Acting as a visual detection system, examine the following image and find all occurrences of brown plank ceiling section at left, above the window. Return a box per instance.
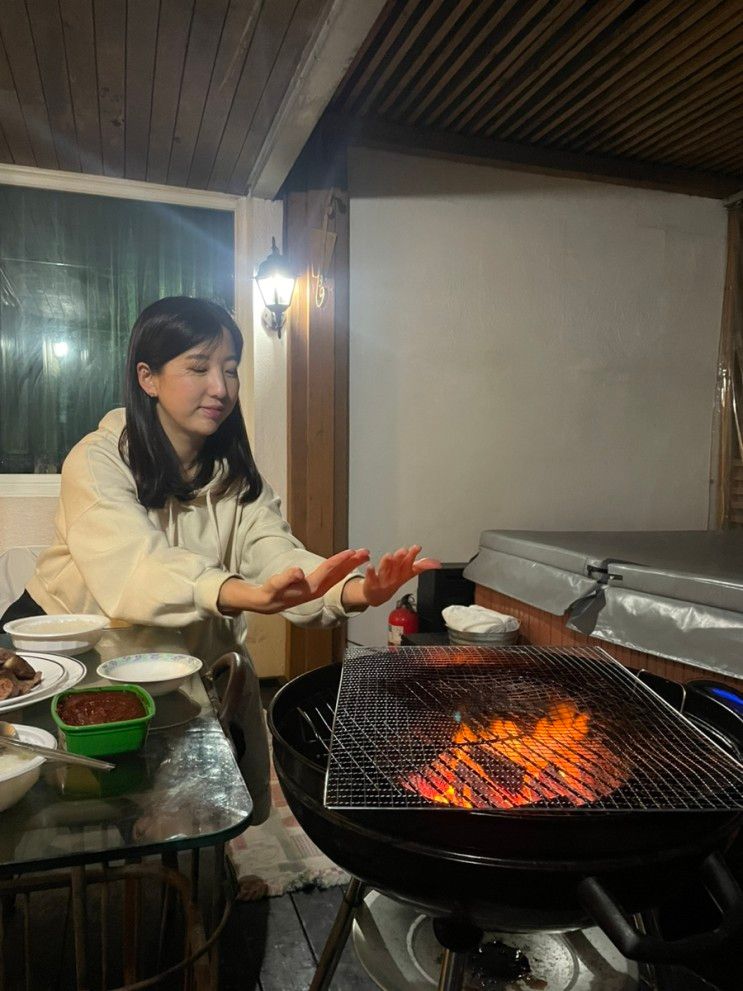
[0,0,328,194]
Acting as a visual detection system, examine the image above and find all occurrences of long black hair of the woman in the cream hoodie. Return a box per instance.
[119,296,263,509]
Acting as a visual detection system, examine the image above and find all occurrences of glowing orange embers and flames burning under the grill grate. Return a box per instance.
[401,701,626,809]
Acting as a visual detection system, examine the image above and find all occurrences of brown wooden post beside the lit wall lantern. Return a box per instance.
[284,131,349,677]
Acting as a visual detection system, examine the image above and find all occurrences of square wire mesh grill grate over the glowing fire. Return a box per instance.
[325,647,743,813]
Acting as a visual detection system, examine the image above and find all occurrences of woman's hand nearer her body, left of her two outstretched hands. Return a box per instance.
[217,549,369,615]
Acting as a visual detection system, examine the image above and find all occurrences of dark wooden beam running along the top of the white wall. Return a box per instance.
[326,115,740,199]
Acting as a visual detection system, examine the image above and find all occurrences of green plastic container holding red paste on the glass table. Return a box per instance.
[52,685,155,757]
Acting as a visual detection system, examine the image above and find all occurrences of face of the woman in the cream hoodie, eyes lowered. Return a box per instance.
[137,330,240,464]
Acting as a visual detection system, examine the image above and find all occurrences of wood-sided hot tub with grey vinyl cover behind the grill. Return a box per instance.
[464,530,743,682]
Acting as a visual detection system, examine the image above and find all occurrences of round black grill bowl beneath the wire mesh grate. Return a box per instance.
[268,665,741,932]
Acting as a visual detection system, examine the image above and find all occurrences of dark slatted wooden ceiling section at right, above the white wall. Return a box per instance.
[330,0,743,188]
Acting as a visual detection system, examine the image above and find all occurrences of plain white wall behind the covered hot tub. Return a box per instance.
[349,150,726,643]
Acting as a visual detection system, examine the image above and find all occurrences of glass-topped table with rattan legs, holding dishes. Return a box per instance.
[0,627,253,987]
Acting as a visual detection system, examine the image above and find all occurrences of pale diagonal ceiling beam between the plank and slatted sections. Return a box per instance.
[248,0,384,199]
